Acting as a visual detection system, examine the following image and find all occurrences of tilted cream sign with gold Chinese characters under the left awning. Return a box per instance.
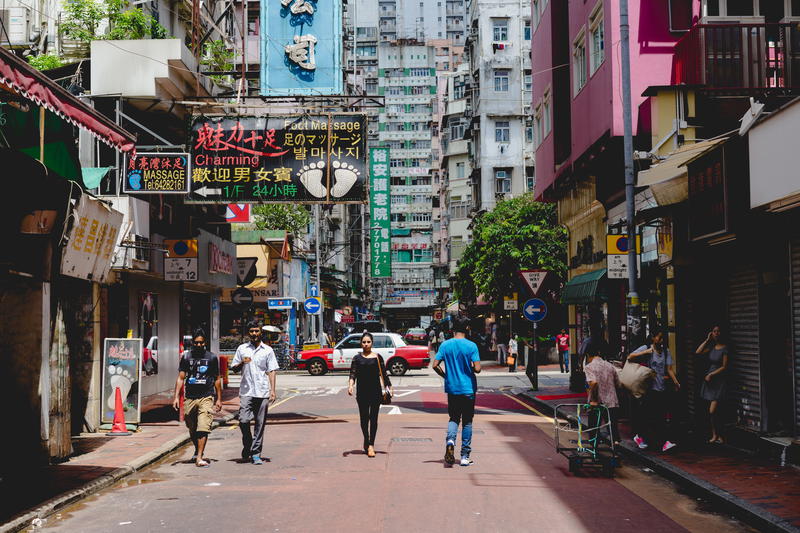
[61,194,123,283]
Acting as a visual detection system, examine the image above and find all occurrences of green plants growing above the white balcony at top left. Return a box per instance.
[61,0,167,42]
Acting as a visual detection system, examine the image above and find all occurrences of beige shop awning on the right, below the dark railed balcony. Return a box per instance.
[637,138,727,205]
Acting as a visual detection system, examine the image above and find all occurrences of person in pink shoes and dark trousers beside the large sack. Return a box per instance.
[628,331,680,452]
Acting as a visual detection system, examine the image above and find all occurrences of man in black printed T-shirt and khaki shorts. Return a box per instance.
[172,329,222,467]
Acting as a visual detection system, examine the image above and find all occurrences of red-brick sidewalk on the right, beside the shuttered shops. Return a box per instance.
[518,380,800,532]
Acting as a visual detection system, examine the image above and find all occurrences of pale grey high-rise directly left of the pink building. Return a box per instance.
[464,0,534,212]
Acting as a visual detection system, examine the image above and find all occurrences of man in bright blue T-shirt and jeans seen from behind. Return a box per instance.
[433,319,481,466]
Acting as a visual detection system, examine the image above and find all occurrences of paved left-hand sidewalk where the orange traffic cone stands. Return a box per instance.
[0,388,239,533]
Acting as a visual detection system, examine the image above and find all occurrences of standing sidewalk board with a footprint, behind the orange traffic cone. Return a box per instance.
[100,339,142,424]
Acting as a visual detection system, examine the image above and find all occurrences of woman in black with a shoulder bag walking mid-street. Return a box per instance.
[347,331,392,457]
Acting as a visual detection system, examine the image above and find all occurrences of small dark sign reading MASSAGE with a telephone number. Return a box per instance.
[122,153,191,194]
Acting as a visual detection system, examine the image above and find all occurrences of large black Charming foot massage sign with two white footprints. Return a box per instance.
[187,114,367,204]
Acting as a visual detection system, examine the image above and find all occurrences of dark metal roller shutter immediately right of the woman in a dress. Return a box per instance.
[728,266,762,431]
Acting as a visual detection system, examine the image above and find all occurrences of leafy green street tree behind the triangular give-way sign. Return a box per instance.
[455,194,567,302]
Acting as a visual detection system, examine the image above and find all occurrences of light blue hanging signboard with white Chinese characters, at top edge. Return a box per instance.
[260,0,342,96]
